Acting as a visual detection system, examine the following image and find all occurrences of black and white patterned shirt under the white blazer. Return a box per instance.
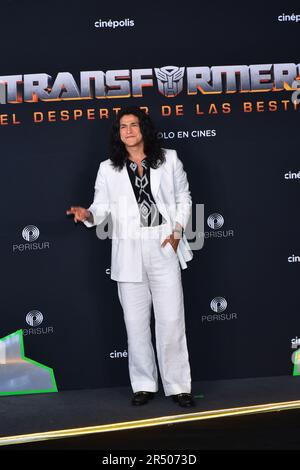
[126,157,166,227]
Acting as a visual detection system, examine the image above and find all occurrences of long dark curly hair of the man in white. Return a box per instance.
[110,106,165,170]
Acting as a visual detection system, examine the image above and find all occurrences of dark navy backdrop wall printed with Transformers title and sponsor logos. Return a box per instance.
[0,0,300,390]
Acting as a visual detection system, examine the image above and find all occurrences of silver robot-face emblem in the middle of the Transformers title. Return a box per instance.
[154,65,185,98]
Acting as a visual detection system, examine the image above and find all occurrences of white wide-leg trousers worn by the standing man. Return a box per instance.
[117,226,191,396]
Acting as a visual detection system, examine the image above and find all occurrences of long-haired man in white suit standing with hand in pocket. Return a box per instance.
[67,107,195,407]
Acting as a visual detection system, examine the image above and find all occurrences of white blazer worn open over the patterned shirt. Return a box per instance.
[84,149,193,282]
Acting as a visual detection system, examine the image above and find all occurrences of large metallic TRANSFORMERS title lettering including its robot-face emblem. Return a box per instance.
[0,63,300,105]
